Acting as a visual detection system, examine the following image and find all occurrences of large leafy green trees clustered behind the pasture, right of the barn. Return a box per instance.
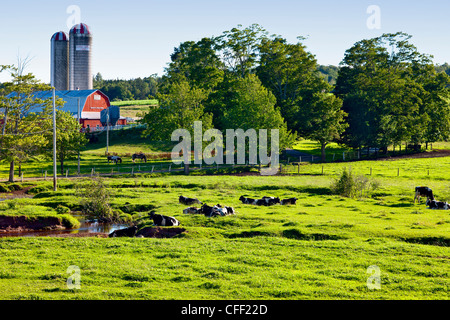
[139,24,450,160]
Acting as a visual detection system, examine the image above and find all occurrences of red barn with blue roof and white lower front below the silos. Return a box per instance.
[5,89,127,131]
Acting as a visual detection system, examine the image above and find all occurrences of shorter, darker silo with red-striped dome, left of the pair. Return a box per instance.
[50,31,69,90]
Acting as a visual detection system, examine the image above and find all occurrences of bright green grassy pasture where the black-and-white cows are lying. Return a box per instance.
[0,158,450,299]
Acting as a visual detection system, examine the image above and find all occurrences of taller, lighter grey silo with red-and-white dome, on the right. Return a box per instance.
[69,23,93,90]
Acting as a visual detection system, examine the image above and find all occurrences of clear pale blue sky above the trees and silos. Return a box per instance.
[0,0,450,82]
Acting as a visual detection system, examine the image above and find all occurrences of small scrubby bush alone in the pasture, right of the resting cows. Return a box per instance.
[331,169,379,198]
